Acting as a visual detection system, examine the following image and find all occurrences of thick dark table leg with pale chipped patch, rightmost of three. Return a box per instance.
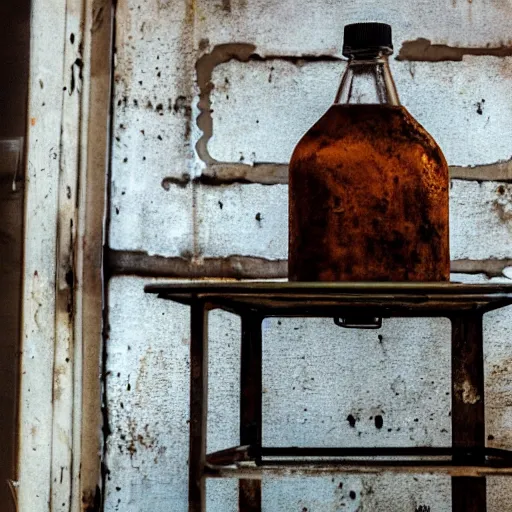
[452,312,487,512]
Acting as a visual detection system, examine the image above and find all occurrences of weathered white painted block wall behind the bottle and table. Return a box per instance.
[106,0,512,512]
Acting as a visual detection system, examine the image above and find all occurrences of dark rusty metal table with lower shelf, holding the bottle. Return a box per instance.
[145,281,512,512]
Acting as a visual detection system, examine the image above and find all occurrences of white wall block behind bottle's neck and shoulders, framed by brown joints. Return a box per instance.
[209,56,512,165]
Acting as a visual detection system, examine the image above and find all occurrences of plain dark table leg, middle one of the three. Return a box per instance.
[238,312,263,512]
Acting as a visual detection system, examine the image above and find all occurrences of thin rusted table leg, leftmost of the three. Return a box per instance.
[188,301,208,512]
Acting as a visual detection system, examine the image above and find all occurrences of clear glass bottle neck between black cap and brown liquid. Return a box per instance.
[334,53,400,105]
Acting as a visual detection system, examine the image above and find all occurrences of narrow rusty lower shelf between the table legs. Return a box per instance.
[205,446,512,480]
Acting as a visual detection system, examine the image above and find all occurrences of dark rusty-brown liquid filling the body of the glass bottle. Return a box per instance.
[288,105,450,281]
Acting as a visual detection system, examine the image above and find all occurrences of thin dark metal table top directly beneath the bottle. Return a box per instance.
[145,280,512,316]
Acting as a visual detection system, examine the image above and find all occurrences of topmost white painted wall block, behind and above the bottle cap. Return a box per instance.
[194,0,510,55]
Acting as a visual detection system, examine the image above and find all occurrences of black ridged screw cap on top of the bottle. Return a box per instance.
[343,23,393,57]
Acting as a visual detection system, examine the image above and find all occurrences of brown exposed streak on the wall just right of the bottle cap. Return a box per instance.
[396,37,512,62]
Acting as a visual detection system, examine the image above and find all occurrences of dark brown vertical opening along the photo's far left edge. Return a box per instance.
[0,0,30,512]
